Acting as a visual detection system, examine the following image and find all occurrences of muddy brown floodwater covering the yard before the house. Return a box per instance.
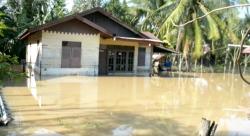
[0,73,250,136]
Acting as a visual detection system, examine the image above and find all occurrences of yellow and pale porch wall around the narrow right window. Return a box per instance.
[100,39,153,75]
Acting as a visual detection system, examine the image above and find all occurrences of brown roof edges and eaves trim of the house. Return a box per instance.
[19,7,163,44]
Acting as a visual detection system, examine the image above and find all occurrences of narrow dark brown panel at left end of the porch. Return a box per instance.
[99,45,107,75]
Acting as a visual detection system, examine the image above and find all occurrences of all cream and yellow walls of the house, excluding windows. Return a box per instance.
[26,31,152,76]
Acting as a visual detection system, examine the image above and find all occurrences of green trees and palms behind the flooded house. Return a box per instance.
[0,0,250,78]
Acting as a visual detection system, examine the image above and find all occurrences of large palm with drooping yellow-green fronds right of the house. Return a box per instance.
[159,0,223,59]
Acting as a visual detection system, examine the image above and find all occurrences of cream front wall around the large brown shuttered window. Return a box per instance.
[42,31,100,75]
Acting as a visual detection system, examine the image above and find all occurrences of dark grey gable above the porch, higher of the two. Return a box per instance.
[83,11,142,38]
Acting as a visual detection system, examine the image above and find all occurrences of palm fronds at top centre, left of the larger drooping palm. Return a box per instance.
[128,0,175,34]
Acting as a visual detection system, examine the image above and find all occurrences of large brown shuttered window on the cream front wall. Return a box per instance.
[61,41,81,68]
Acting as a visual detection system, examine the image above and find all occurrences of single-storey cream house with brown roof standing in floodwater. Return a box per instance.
[20,8,171,76]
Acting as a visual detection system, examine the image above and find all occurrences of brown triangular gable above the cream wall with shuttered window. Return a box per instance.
[45,19,98,34]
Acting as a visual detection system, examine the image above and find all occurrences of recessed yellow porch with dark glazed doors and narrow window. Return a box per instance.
[98,39,153,75]
